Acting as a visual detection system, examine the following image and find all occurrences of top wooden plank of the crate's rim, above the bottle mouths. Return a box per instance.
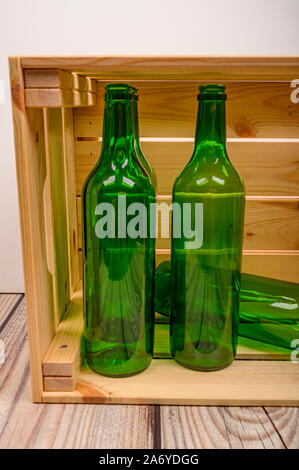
[21,55,299,81]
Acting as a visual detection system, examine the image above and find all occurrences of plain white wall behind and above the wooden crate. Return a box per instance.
[0,0,299,292]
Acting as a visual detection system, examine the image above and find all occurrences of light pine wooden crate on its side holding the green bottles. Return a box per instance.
[9,57,299,405]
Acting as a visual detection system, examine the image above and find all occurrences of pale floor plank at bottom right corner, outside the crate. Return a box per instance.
[266,407,299,449]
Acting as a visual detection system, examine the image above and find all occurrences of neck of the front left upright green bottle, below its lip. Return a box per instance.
[102,100,133,157]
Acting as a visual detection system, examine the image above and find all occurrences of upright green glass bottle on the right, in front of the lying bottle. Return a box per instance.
[170,85,245,371]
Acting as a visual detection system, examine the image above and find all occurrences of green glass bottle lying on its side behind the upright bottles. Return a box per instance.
[155,261,299,350]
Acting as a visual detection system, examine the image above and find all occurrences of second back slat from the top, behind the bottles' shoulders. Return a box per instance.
[75,141,299,196]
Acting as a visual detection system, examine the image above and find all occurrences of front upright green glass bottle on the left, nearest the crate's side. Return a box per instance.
[82,84,155,377]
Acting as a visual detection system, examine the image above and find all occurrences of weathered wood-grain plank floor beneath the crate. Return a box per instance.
[0,294,299,449]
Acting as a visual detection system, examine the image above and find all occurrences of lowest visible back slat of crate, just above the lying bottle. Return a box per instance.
[156,250,299,282]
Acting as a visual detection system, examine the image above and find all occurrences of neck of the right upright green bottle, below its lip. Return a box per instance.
[195,100,226,146]
